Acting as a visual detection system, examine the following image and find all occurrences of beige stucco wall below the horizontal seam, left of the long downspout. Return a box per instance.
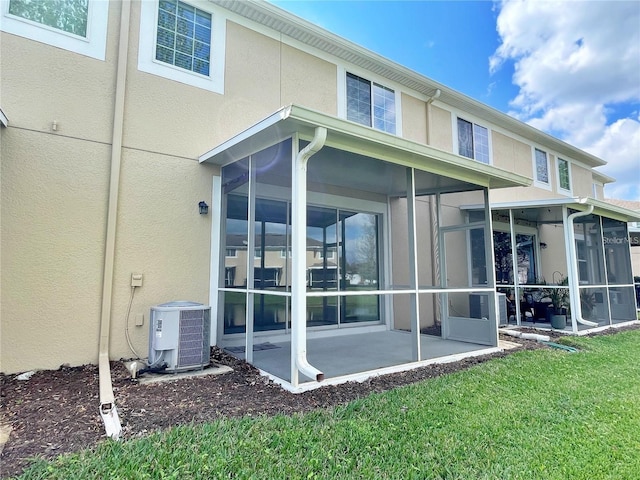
[0,128,110,373]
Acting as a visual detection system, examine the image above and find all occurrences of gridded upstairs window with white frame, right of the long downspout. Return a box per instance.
[138,0,226,93]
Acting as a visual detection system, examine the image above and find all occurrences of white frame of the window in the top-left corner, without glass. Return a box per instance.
[0,0,109,61]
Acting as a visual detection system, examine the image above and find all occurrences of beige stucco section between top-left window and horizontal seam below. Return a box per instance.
[0,32,115,142]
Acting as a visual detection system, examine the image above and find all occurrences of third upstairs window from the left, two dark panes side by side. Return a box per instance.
[347,73,396,134]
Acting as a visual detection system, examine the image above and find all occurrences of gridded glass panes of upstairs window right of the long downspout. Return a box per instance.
[156,0,211,75]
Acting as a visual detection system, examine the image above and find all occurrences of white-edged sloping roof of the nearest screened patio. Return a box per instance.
[199,105,531,191]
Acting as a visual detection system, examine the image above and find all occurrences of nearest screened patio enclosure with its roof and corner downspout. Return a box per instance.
[200,105,529,391]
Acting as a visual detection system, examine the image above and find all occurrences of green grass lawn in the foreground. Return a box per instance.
[13,330,640,480]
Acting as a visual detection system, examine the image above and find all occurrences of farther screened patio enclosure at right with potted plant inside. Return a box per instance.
[463,198,638,333]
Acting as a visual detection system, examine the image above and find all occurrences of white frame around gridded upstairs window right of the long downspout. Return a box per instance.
[138,0,227,94]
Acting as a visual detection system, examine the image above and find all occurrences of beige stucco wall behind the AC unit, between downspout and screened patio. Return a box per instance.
[111,150,217,358]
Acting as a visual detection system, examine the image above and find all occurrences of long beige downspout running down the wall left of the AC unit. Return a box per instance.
[98,0,131,440]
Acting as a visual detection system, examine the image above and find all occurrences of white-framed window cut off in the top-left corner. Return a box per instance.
[0,0,109,60]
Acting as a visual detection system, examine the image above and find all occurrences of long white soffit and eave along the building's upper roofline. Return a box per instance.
[209,0,607,167]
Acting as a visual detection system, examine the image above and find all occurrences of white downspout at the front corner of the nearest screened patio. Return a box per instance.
[291,127,327,387]
